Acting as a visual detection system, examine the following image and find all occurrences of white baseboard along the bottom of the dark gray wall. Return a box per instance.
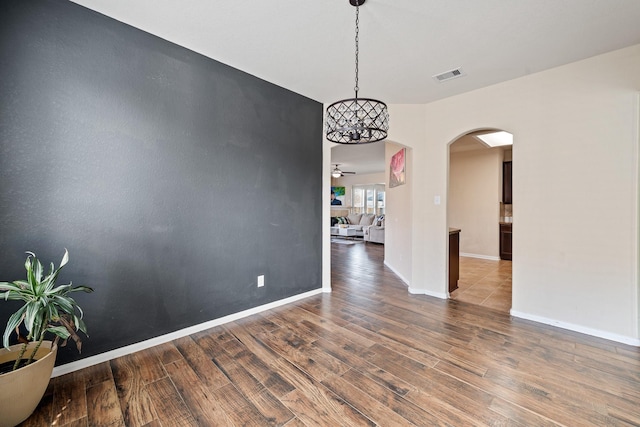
[51,288,326,378]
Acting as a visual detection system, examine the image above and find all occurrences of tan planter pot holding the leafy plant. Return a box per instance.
[0,341,58,427]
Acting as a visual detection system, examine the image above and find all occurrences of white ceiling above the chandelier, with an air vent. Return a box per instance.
[74,0,640,174]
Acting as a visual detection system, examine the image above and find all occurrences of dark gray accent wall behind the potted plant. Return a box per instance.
[0,0,322,364]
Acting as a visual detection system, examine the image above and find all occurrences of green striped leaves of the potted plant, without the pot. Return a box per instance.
[0,249,93,370]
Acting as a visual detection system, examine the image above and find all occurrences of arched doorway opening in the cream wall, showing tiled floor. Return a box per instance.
[447,129,514,312]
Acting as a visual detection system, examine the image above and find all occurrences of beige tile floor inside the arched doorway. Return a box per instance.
[451,257,511,313]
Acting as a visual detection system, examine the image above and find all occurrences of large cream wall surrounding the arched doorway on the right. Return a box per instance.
[385,45,640,344]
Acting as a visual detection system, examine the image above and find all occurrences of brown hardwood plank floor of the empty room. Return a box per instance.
[23,244,640,427]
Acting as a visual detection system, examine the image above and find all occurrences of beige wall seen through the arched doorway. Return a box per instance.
[447,143,503,259]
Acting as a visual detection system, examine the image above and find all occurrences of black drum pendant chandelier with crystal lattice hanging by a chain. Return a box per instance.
[326,0,389,144]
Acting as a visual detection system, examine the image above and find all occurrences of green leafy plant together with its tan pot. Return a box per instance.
[0,249,93,427]
